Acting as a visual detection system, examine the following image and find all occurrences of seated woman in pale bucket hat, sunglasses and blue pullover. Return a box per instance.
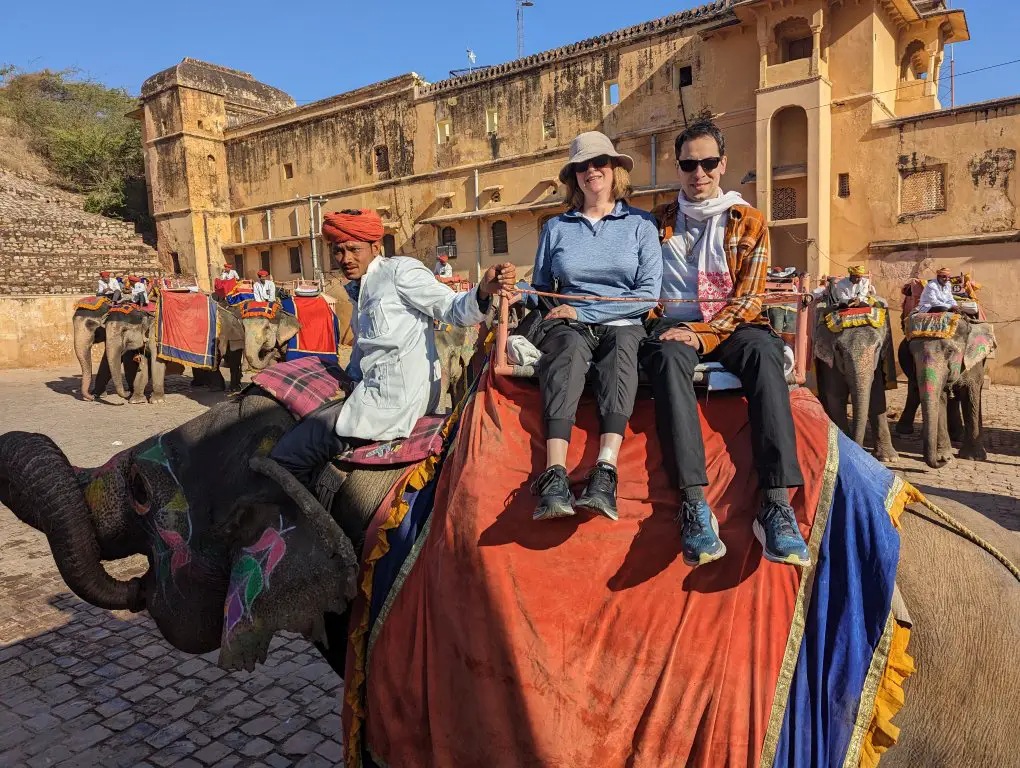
[532,131,662,520]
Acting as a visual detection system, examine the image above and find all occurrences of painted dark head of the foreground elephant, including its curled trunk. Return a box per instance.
[0,396,356,669]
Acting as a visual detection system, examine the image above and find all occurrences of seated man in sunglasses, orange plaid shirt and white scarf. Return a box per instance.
[641,120,811,566]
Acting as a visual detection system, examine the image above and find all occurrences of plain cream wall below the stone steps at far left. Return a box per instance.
[0,296,79,369]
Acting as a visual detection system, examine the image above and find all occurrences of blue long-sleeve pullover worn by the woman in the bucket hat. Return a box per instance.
[531,200,662,323]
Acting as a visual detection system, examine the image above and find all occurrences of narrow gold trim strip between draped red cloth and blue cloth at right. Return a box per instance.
[758,421,839,768]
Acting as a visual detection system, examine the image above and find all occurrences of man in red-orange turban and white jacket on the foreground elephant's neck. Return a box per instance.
[270,209,516,490]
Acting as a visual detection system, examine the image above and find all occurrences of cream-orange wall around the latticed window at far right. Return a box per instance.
[831,104,1020,383]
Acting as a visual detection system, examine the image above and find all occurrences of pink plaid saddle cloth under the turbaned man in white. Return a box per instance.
[252,357,446,466]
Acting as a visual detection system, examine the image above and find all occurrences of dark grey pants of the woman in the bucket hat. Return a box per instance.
[539,320,645,440]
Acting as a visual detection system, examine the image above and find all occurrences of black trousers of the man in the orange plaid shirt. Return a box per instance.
[640,320,804,489]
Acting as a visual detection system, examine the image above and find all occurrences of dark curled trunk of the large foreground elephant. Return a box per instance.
[0,432,145,611]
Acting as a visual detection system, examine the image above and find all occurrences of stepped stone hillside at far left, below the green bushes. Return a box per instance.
[0,169,160,296]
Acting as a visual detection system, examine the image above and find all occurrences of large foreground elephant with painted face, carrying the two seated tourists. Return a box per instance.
[0,387,1020,768]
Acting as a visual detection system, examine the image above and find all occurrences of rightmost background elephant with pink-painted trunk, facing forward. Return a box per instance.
[897,315,996,469]
